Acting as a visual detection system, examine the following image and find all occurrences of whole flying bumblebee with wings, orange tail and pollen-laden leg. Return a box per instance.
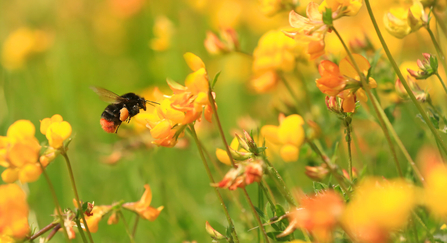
[90,87,158,133]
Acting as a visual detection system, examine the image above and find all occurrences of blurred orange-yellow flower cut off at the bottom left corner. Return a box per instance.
[0,184,29,238]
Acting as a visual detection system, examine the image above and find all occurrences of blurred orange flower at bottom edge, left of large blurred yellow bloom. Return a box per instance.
[277,191,344,242]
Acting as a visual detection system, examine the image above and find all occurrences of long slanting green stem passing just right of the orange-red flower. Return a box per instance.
[332,28,403,177]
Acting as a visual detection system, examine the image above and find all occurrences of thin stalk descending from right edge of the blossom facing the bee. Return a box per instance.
[208,89,270,243]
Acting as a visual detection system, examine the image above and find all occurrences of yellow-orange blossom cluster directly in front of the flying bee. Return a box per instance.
[136,52,213,147]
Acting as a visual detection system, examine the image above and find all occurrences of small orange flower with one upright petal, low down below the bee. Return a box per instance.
[123,184,164,221]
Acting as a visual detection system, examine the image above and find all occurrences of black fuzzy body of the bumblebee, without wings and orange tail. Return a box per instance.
[101,93,146,126]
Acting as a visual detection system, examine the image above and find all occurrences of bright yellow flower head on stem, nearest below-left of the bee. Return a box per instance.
[40,114,72,149]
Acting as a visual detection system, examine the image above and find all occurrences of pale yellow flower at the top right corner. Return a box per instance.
[383,0,428,39]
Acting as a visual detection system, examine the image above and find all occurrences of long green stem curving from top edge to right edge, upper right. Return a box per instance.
[365,0,447,156]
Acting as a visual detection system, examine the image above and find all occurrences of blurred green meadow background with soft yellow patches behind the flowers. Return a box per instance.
[0,0,444,242]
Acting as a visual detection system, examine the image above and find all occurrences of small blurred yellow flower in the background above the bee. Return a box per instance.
[150,16,174,51]
